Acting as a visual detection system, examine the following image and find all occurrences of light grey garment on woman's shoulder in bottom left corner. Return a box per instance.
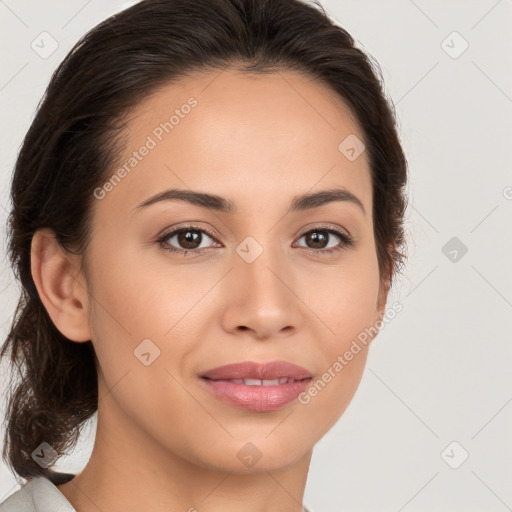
[0,476,76,512]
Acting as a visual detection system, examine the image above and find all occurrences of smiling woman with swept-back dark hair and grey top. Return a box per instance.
[0,0,406,512]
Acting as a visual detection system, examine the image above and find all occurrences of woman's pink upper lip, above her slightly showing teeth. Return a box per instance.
[201,361,311,380]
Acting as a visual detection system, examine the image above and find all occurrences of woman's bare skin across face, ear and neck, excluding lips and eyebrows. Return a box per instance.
[32,70,388,512]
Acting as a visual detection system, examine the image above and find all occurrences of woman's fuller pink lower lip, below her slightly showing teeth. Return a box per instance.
[201,377,311,412]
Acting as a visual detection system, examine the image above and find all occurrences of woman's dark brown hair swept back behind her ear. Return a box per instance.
[1,0,407,481]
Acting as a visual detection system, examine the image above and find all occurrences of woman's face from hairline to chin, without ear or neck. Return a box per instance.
[74,70,385,472]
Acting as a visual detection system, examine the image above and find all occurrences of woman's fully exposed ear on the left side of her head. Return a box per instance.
[30,228,91,342]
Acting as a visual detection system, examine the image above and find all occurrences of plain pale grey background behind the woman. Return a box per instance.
[0,0,512,512]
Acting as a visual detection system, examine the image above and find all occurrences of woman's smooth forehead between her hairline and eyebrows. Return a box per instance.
[98,70,371,218]
